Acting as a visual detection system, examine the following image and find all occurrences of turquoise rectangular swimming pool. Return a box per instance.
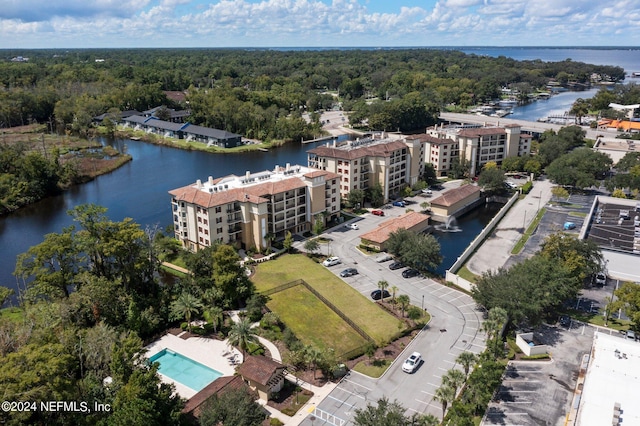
[149,349,222,392]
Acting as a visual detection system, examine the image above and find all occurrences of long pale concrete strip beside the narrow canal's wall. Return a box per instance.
[466,180,553,275]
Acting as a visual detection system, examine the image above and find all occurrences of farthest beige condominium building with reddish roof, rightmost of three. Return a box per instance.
[425,124,532,176]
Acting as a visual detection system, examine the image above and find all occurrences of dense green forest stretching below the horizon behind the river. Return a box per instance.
[0,49,624,141]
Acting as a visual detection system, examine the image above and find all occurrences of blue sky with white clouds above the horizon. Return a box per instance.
[0,0,640,49]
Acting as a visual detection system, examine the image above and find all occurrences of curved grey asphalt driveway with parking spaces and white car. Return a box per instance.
[298,211,486,425]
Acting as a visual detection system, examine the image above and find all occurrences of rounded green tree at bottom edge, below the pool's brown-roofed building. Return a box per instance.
[198,389,268,426]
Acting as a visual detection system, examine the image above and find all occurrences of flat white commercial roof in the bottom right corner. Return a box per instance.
[576,332,640,426]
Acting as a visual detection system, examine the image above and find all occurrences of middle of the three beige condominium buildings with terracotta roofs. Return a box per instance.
[307,134,424,201]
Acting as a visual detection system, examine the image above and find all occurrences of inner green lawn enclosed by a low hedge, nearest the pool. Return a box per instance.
[267,285,367,355]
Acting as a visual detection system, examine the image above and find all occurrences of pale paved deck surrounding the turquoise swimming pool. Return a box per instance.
[145,334,242,399]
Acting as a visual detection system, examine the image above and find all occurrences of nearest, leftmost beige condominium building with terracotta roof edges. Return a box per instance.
[169,164,340,251]
